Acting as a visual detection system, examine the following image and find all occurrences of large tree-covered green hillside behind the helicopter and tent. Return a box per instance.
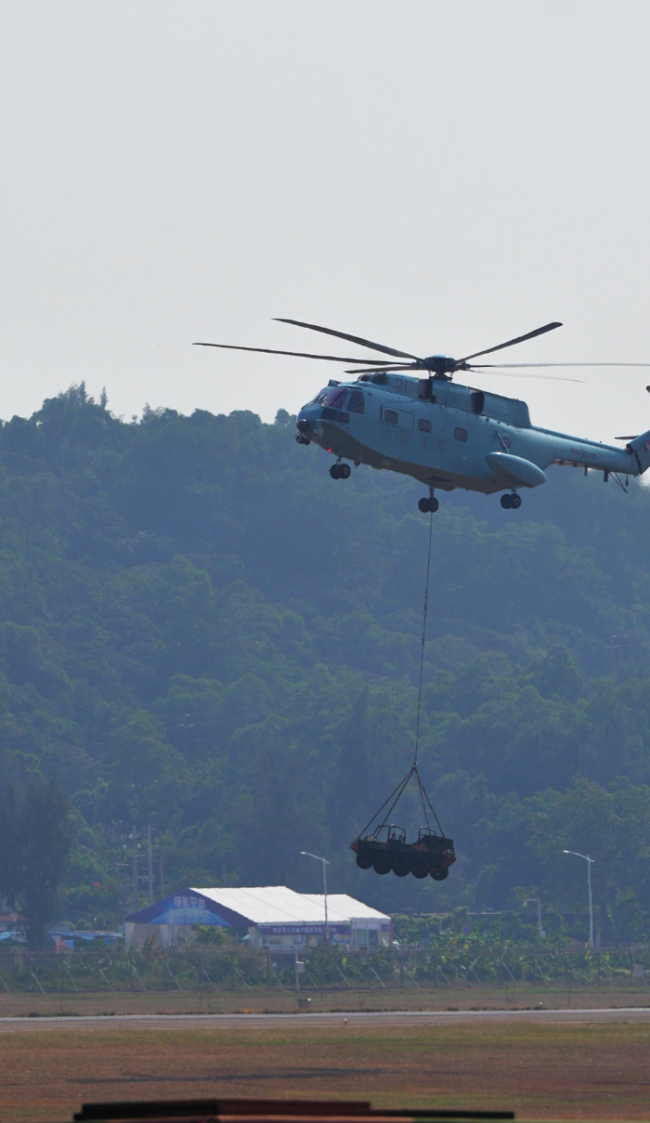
[0,387,650,939]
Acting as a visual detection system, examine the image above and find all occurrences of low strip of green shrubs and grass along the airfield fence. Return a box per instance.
[6,934,650,997]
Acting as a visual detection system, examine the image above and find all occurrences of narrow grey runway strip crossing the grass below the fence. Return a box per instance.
[0,1006,650,1033]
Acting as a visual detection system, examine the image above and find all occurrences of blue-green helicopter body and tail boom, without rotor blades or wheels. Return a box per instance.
[297,373,650,494]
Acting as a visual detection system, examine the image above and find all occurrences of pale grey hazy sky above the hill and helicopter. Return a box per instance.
[0,0,650,439]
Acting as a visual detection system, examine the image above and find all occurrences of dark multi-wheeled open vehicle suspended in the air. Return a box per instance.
[351,824,456,882]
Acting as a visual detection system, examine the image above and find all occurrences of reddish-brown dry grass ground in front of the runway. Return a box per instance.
[0,1016,650,1123]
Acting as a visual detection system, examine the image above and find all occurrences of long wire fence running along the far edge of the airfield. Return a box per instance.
[0,944,650,1004]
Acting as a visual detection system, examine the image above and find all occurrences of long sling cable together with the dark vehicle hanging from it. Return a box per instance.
[351,514,456,882]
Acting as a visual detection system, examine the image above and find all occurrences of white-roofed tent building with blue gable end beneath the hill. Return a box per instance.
[125,885,392,952]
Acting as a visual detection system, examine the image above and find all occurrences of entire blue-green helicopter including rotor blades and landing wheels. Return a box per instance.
[195,318,650,512]
